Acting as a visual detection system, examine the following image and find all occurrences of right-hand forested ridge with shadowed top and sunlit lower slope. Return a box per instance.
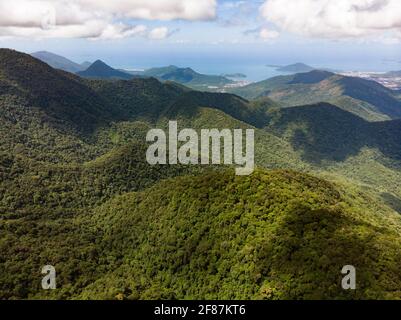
[265,103,401,208]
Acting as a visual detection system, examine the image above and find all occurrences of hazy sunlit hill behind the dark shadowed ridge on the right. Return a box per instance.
[230,70,401,121]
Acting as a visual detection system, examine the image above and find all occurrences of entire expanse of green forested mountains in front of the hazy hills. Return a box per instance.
[0,49,401,299]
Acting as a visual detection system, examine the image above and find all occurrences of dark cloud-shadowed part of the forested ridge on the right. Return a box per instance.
[269,103,401,161]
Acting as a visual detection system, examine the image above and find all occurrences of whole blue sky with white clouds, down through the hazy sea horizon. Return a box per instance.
[0,0,401,72]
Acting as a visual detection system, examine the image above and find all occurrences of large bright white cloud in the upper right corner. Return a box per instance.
[260,0,401,39]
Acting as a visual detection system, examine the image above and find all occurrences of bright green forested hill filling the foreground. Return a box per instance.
[5,171,401,299]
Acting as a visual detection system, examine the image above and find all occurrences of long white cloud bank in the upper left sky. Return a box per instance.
[0,0,216,39]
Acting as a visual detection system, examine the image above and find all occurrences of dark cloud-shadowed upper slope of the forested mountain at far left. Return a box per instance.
[0,49,113,141]
